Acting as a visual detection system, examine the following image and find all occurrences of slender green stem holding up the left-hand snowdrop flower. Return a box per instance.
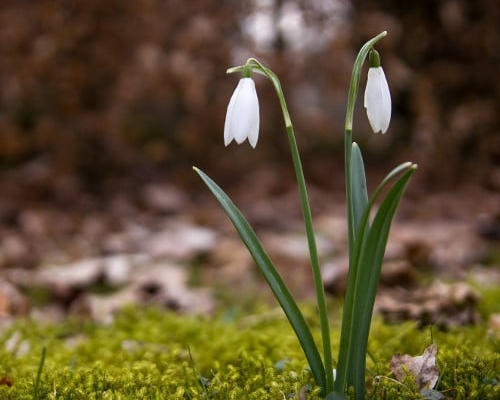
[247,58,333,394]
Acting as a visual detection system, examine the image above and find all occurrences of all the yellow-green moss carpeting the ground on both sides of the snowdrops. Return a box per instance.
[0,289,500,400]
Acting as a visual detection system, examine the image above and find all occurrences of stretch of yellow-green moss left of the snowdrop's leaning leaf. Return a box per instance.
[0,309,317,399]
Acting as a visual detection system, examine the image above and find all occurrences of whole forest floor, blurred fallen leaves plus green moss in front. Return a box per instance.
[0,164,500,399]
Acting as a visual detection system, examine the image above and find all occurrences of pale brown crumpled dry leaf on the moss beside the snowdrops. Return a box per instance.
[390,344,439,392]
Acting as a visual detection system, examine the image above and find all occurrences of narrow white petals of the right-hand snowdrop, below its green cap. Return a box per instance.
[365,67,391,133]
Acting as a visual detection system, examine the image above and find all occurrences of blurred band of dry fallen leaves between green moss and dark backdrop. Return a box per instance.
[0,162,500,326]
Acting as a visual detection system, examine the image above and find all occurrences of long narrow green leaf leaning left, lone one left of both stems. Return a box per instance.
[193,168,326,390]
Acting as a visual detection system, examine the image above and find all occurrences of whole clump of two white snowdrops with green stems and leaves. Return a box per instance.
[195,32,416,400]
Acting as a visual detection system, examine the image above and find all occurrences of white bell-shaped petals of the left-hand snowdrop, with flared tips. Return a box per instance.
[224,78,259,148]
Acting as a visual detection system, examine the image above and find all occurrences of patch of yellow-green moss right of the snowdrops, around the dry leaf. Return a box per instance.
[368,320,500,400]
